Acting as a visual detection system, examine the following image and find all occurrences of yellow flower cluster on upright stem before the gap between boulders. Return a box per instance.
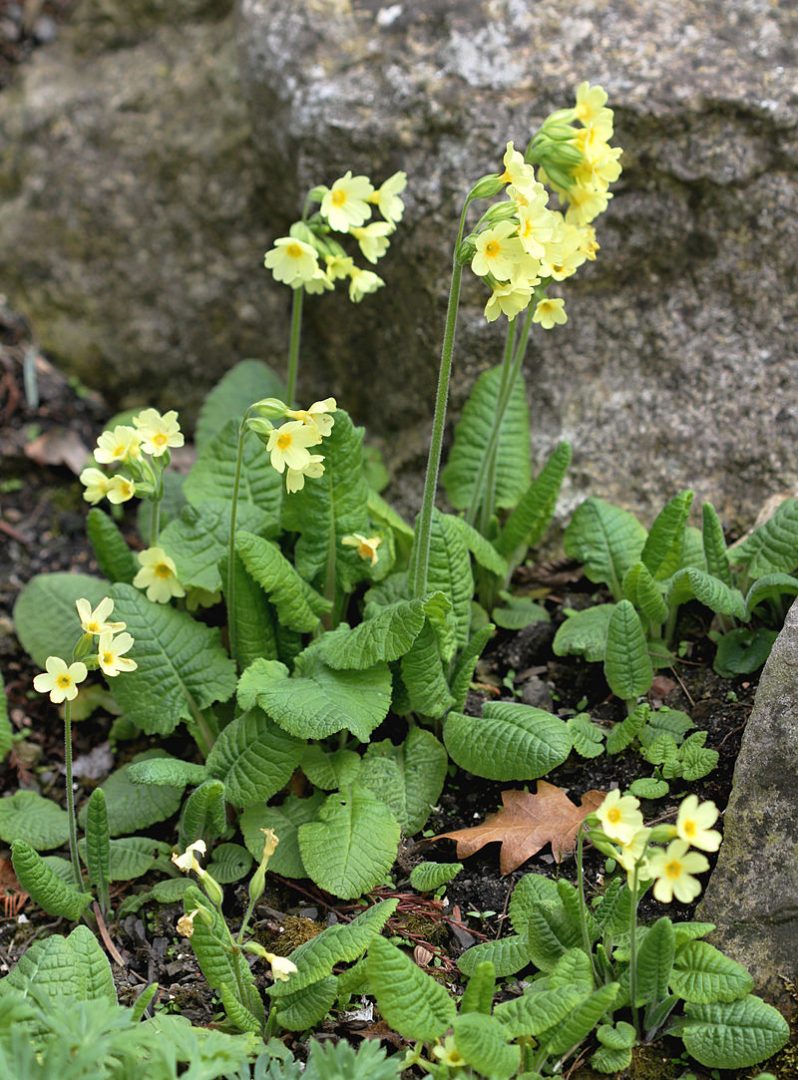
[263,171,407,303]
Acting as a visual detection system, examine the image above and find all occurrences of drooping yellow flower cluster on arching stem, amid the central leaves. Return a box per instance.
[247,397,338,495]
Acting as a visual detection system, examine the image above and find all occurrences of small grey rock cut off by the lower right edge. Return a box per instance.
[698,603,798,1011]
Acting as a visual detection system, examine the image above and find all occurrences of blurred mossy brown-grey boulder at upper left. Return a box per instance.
[0,0,287,409]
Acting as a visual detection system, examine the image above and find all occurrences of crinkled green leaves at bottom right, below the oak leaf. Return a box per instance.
[359,874,789,1080]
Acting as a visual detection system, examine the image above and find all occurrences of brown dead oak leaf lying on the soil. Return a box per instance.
[435,780,605,874]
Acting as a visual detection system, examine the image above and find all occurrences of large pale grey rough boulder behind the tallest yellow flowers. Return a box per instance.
[238,0,798,523]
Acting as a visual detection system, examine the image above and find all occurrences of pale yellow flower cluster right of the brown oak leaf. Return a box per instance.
[596,791,721,904]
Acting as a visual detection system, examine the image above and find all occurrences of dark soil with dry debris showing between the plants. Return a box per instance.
[0,315,795,1080]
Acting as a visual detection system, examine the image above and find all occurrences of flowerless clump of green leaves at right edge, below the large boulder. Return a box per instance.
[554,490,798,682]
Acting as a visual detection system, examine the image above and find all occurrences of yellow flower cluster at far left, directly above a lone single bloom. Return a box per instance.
[80,408,184,504]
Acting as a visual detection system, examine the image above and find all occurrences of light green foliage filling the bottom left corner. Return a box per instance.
[0,927,259,1080]
